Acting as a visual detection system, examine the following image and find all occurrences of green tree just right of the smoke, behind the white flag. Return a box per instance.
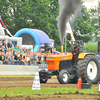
[73,6,95,42]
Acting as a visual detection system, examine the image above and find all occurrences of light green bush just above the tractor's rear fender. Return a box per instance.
[83,42,98,55]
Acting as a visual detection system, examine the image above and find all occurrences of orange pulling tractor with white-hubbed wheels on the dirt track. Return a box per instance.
[39,42,100,84]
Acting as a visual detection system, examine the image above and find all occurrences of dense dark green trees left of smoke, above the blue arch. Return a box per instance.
[0,0,60,45]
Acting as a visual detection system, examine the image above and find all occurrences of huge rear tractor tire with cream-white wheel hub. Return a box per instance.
[76,55,100,84]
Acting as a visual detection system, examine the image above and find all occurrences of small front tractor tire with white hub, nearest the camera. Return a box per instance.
[57,70,69,84]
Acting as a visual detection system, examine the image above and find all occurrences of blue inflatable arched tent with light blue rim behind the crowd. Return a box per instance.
[14,28,52,52]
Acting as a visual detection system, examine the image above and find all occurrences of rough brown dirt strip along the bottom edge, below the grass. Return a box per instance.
[0,91,100,100]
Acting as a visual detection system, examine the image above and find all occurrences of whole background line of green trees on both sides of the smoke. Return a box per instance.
[0,0,100,51]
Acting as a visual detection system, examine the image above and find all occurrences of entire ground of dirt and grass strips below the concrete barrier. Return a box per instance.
[0,75,100,100]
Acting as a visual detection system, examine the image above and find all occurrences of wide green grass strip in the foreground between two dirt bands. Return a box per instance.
[0,87,99,97]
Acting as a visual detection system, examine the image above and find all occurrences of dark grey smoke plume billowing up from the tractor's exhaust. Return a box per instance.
[57,0,94,45]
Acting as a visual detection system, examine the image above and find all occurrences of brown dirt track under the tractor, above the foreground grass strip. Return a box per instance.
[0,77,98,88]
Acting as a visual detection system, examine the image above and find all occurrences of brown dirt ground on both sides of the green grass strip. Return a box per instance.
[0,77,100,100]
